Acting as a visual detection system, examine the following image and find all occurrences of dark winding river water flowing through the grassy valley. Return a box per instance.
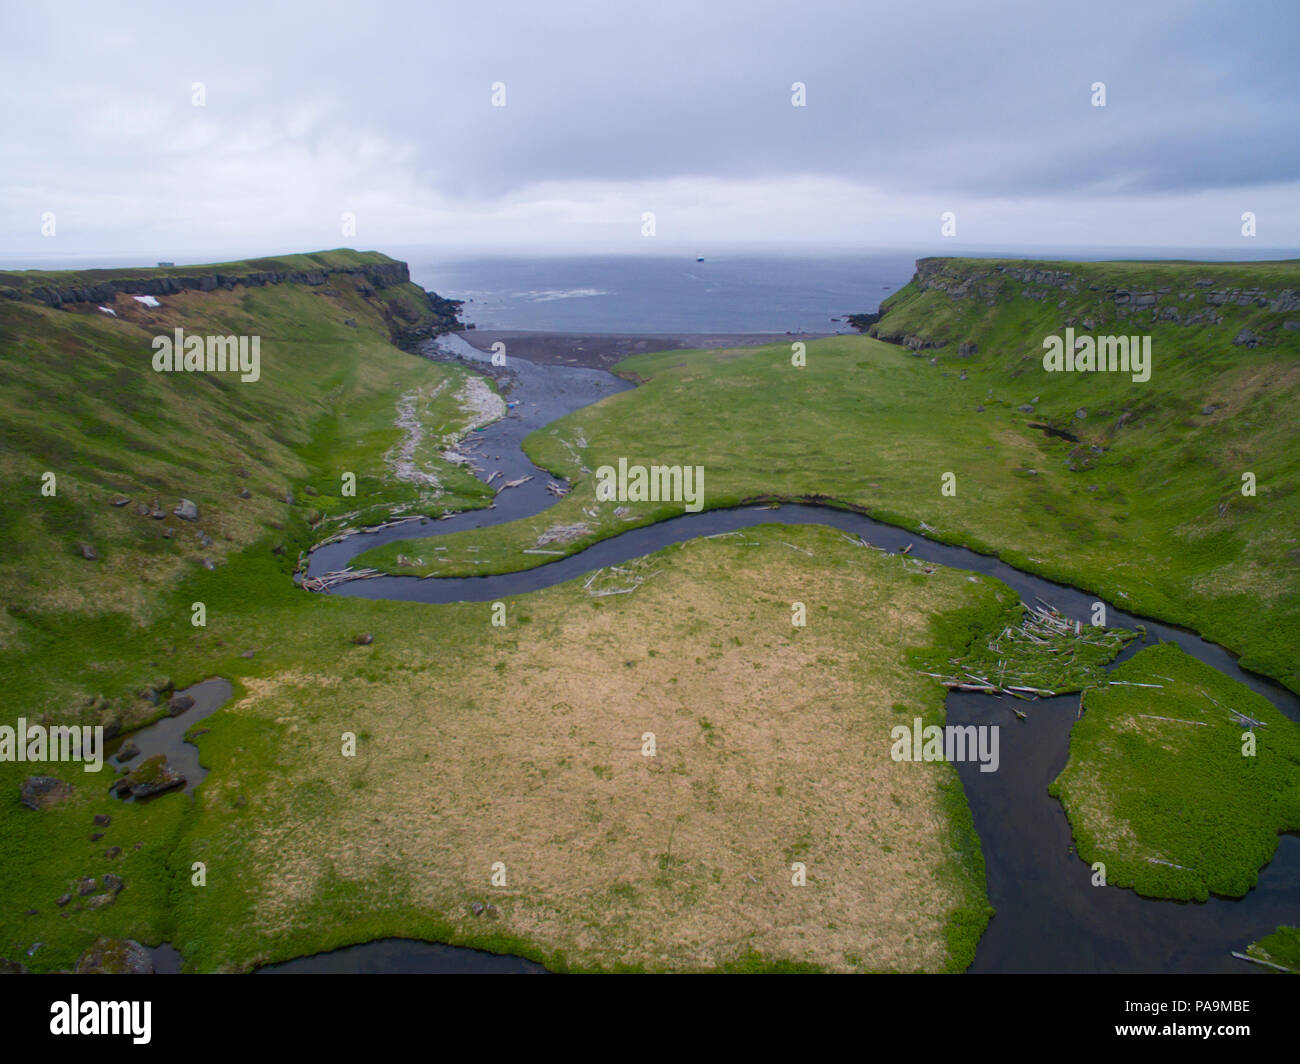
[142,337,1300,973]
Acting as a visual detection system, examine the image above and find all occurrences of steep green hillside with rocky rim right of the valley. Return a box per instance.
[870,259,1300,689]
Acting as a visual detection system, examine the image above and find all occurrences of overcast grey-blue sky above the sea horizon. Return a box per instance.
[0,0,1300,263]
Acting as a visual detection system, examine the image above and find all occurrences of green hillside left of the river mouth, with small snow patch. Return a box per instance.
[0,251,490,722]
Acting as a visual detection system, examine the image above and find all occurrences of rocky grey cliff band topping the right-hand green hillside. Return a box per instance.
[868,259,1300,350]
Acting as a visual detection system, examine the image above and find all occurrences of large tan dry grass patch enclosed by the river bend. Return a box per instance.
[188,525,983,970]
